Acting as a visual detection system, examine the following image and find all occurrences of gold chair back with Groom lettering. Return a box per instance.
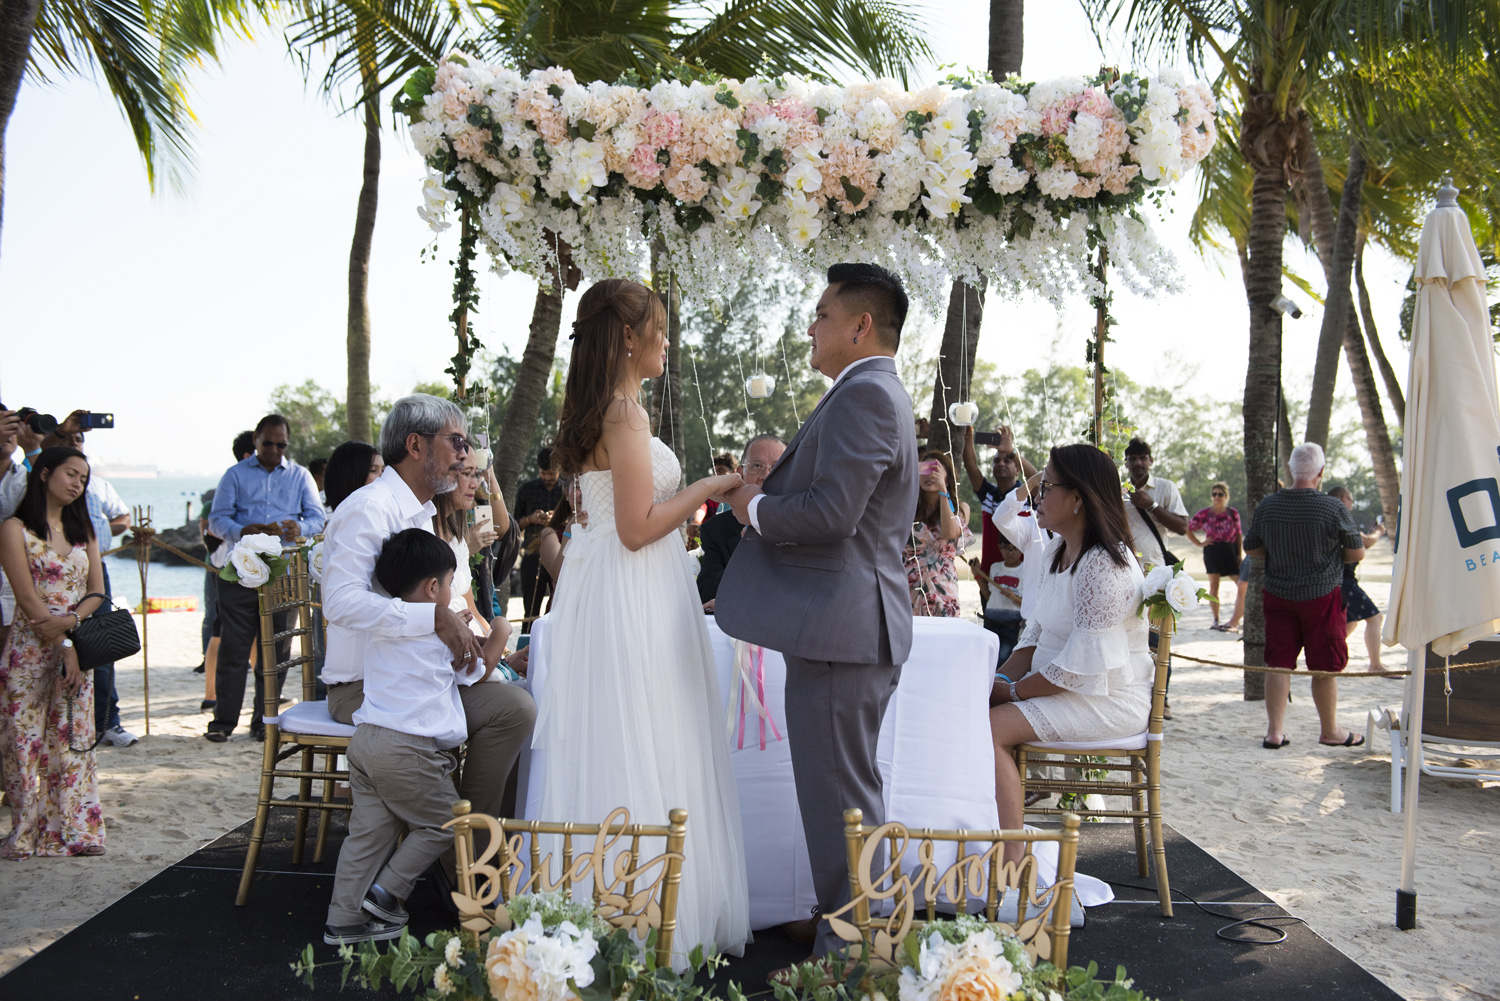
[825,810,1079,969]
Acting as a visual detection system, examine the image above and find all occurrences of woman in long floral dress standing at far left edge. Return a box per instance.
[0,449,104,858]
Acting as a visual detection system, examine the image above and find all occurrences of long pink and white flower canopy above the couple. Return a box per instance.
[396,53,1218,305]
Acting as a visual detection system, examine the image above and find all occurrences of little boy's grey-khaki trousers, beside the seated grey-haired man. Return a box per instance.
[329,723,453,927]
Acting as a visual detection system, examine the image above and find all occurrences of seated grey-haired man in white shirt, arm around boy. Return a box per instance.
[323,393,537,918]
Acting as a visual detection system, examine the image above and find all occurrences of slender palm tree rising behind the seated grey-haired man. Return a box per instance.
[287,0,464,441]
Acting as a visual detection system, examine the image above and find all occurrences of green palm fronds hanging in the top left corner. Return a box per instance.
[0,0,263,258]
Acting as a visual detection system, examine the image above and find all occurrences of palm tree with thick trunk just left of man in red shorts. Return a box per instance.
[1083,0,1500,698]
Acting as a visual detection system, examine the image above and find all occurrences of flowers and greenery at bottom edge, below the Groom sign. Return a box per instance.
[771,915,1146,1001]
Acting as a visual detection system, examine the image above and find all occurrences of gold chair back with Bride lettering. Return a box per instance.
[447,800,687,966]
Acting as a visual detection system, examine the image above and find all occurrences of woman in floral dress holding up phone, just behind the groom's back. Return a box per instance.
[903,452,974,618]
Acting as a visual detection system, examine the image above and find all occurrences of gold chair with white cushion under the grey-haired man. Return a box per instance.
[234,549,354,906]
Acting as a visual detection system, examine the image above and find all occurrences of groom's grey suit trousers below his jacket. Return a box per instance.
[785,654,902,956]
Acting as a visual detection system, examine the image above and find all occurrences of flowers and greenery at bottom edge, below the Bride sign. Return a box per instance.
[293,891,743,1001]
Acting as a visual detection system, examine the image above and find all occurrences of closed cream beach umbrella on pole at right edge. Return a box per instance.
[1383,182,1500,929]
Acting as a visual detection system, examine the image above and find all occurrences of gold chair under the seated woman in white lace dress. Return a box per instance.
[1016,615,1175,917]
